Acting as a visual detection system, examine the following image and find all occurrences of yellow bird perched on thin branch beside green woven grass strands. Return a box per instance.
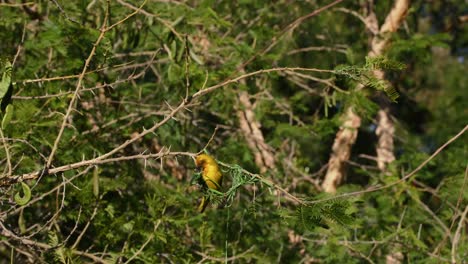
[195,154,223,213]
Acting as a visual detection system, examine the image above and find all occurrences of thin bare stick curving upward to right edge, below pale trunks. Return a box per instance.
[308,125,468,204]
